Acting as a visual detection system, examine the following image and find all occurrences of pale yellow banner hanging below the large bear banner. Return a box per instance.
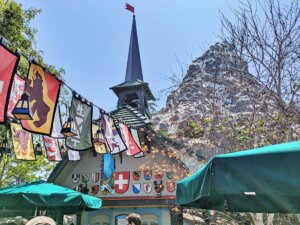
[10,123,35,160]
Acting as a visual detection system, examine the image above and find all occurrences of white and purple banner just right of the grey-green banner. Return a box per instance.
[101,113,127,155]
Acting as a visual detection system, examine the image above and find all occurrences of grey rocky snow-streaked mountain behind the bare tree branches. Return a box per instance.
[152,42,278,166]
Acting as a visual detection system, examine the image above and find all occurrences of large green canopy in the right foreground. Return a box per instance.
[176,141,300,213]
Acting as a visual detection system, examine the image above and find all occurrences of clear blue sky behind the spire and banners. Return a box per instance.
[17,0,238,112]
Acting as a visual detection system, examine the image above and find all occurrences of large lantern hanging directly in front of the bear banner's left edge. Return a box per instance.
[12,92,32,120]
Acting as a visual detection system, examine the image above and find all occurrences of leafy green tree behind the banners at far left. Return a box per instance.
[0,0,64,187]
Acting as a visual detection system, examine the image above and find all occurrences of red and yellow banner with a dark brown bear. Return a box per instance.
[21,64,60,135]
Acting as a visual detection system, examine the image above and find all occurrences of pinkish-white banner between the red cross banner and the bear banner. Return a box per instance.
[7,75,25,118]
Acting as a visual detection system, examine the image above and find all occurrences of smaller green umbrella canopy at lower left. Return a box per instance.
[0,181,102,210]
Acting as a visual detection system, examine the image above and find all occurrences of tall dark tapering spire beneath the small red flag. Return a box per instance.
[125,15,143,81]
